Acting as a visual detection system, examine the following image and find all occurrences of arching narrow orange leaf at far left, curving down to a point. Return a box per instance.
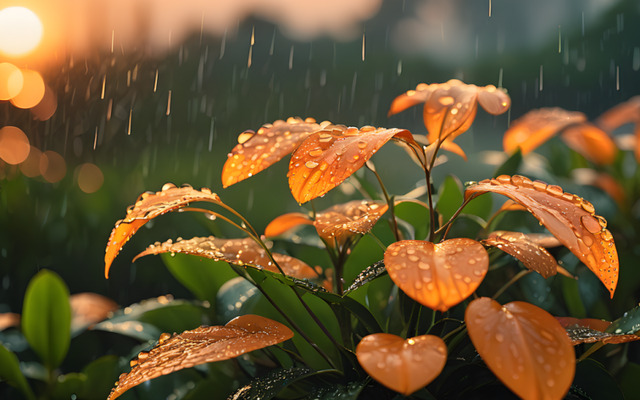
[104,183,222,279]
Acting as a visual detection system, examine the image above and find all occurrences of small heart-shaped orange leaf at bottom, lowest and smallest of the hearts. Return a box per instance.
[356,333,447,396]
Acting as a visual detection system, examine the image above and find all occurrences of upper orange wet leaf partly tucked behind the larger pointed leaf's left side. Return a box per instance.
[222,118,329,187]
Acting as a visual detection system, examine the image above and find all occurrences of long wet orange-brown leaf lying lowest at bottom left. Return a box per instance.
[107,315,293,400]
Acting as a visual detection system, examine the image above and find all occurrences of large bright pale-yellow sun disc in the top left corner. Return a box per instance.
[0,7,43,57]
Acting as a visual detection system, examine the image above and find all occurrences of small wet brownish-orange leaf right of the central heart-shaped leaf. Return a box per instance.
[482,231,558,278]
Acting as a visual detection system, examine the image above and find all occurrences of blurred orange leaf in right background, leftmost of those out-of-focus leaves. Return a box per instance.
[502,108,587,154]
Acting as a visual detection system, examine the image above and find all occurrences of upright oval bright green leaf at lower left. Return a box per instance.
[22,270,71,370]
